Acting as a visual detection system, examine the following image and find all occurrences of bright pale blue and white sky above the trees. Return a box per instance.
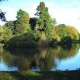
[0,0,80,32]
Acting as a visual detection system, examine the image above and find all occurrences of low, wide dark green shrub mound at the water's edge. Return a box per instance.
[4,31,40,48]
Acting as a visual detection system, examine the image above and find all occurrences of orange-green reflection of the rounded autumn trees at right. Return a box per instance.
[55,44,79,59]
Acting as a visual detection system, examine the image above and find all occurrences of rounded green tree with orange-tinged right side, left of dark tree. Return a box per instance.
[15,9,30,34]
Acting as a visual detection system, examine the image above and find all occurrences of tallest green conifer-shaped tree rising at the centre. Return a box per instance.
[35,2,54,42]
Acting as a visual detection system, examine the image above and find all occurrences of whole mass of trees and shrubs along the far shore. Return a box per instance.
[0,2,79,48]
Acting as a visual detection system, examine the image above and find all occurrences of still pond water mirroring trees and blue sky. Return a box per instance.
[0,44,80,71]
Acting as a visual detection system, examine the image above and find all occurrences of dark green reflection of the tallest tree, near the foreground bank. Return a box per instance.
[39,48,56,71]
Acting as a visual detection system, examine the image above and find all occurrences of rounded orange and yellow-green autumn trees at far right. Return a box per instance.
[55,24,79,40]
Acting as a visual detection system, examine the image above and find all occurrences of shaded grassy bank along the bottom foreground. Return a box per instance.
[0,70,80,80]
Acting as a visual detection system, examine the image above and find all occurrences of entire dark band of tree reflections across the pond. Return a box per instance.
[0,44,79,71]
